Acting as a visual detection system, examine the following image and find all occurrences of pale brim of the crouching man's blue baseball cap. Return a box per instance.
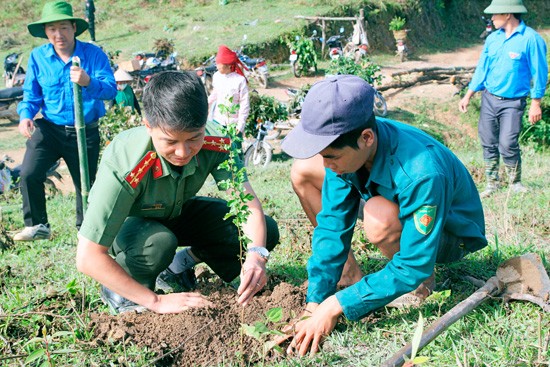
[281,123,340,159]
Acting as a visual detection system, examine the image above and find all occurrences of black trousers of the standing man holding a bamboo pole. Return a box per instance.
[20,119,99,228]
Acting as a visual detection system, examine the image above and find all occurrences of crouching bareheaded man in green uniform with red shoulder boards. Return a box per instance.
[77,71,279,313]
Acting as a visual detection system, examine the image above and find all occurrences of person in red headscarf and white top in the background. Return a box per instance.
[208,45,250,144]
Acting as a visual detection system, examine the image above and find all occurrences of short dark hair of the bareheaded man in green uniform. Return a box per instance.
[143,71,208,131]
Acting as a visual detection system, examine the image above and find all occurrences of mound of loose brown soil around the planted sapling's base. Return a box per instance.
[90,280,305,366]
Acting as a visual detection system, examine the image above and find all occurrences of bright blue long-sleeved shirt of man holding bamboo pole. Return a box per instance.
[17,40,117,126]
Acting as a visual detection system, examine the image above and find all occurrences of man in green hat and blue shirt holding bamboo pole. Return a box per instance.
[13,1,116,241]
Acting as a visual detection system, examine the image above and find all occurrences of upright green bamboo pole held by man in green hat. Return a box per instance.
[73,56,90,214]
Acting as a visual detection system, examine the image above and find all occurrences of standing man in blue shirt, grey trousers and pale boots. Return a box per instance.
[458,0,548,197]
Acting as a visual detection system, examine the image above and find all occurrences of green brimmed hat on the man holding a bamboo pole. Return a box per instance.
[27,1,88,38]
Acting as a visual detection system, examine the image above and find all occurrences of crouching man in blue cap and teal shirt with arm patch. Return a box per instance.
[278,75,487,356]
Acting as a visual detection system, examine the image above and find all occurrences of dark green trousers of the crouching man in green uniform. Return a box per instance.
[111,196,279,289]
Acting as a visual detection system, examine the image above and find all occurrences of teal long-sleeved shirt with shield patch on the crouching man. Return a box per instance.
[307,117,487,320]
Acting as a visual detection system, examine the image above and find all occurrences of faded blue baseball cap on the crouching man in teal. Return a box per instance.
[281,75,374,159]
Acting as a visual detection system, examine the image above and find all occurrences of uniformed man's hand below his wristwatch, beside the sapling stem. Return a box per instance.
[237,252,267,306]
